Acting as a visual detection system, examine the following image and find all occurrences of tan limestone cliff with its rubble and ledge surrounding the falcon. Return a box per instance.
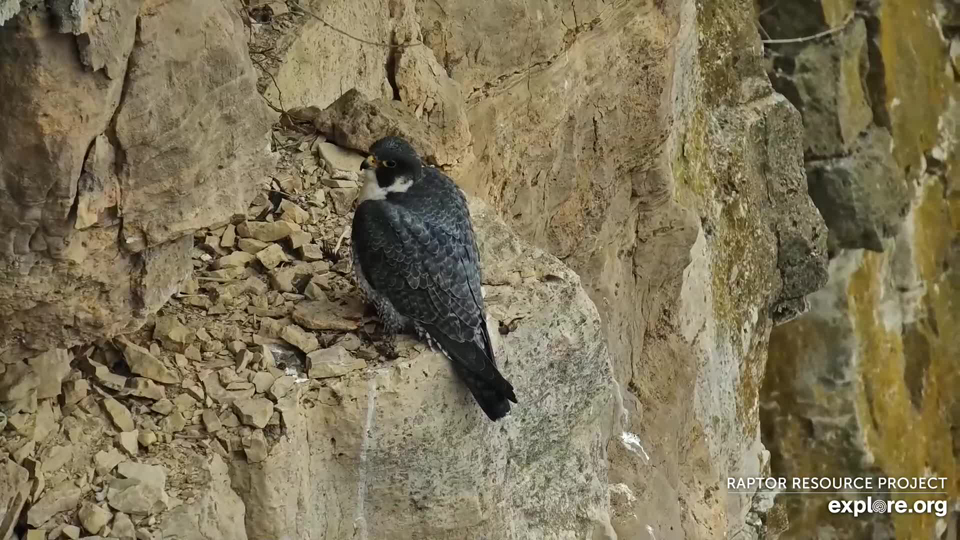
[0,0,832,540]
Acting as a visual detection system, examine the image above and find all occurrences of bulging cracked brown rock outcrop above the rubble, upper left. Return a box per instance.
[0,0,271,354]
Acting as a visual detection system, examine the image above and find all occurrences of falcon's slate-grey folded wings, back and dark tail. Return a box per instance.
[352,168,517,420]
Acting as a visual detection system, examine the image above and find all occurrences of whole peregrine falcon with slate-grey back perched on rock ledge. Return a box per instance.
[352,137,517,420]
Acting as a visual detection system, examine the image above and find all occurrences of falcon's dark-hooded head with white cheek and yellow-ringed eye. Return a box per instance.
[360,137,423,202]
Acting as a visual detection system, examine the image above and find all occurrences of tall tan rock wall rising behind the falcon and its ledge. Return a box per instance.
[254,0,827,538]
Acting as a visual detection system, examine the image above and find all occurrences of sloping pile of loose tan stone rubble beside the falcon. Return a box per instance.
[0,126,424,540]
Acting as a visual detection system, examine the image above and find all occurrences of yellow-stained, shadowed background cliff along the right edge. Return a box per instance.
[760,0,960,539]
